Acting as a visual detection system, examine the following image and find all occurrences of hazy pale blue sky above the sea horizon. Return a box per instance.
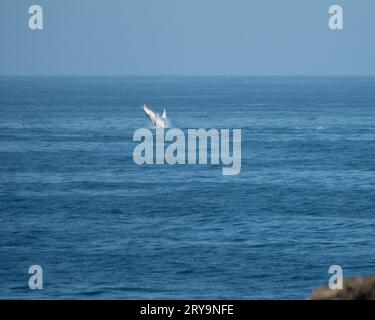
[0,0,375,75]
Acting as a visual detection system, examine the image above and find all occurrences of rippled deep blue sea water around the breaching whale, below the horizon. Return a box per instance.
[0,77,375,299]
